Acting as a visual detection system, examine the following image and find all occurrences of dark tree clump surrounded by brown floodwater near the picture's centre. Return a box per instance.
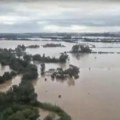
[51,65,79,79]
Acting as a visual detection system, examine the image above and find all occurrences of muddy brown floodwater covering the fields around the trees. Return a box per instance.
[0,41,120,120]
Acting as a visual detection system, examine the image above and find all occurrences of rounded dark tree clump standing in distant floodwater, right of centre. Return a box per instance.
[71,44,92,53]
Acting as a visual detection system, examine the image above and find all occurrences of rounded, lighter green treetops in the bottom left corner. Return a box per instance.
[0,104,39,120]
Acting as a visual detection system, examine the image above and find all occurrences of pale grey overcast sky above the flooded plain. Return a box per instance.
[0,0,120,33]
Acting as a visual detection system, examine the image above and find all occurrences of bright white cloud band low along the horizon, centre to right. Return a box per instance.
[43,25,120,33]
